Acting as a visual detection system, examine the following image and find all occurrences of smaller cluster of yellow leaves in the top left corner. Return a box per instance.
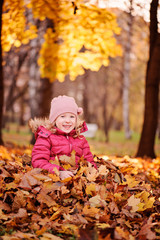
[1,0,37,52]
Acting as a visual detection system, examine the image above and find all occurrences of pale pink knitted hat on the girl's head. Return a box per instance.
[49,95,83,122]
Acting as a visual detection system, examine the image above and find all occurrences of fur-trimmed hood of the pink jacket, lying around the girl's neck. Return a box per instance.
[28,118,88,134]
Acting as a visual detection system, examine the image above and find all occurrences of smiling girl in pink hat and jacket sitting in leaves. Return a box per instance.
[29,95,96,179]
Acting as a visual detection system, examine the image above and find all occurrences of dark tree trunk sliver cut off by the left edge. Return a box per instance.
[0,0,4,145]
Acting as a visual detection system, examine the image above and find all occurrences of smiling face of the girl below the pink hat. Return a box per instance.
[56,113,76,133]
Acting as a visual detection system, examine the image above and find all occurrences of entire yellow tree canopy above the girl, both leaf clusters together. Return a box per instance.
[2,0,122,81]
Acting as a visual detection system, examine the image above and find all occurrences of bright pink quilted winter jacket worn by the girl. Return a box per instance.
[29,118,97,173]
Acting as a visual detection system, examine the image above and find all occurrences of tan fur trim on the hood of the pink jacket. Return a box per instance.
[28,118,88,134]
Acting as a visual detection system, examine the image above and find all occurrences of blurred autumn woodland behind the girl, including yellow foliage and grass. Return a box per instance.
[1,0,160,156]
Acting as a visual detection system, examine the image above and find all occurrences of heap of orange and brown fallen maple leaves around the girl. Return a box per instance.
[0,144,160,240]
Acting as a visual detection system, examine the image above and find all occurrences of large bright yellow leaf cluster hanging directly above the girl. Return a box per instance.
[31,0,121,82]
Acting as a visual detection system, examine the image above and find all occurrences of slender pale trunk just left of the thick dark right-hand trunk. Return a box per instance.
[123,0,133,139]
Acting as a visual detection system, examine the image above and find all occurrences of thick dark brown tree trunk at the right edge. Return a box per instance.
[136,0,160,158]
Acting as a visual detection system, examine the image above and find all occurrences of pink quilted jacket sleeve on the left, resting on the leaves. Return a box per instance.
[32,136,64,173]
